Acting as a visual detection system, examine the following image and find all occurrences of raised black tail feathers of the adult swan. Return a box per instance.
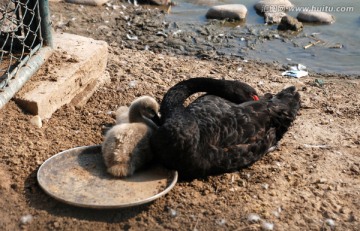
[269,86,300,140]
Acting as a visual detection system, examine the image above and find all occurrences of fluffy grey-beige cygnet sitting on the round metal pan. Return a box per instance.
[102,96,159,177]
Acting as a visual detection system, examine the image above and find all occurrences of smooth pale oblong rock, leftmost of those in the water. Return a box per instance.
[206,4,247,20]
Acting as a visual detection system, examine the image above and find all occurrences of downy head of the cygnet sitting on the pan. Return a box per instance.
[129,95,160,122]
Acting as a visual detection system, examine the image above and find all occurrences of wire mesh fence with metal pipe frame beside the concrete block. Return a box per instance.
[0,0,51,108]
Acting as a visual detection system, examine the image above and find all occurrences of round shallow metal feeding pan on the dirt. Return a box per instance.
[37,145,178,209]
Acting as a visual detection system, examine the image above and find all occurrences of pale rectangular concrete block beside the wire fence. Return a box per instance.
[14,33,110,119]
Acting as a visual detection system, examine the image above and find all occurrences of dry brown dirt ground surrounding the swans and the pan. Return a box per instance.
[0,0,360,230]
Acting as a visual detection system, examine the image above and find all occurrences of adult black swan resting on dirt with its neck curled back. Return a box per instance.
[151,78,300,178]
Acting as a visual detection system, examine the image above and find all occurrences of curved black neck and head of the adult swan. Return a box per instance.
[160,78,256,121]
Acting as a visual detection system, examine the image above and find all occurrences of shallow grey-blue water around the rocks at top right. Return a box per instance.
[167,0,360,75]
